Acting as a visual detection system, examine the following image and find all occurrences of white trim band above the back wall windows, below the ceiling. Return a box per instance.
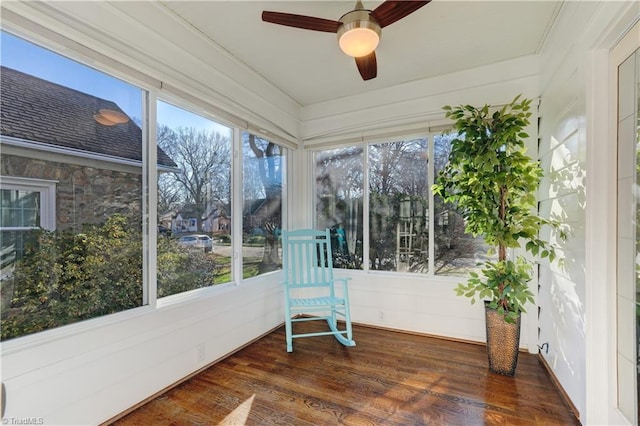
[300,55,539,143]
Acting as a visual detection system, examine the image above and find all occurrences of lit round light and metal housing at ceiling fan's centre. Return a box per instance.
[338,9,382,58]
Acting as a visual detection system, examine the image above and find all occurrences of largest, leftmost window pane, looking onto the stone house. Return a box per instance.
[0,32,145,340]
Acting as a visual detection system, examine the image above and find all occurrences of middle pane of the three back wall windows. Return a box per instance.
[369,139,429,273]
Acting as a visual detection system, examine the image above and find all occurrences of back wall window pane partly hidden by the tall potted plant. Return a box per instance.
[433,134,489,276]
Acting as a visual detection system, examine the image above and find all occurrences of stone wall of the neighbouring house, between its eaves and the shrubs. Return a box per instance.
[0,154,142,231]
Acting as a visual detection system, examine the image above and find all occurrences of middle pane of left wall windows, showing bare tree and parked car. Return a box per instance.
[157,101,232,297]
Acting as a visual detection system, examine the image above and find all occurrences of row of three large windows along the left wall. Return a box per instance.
[0,32,286,340]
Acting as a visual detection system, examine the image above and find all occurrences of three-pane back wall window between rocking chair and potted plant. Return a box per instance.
[314,135,486,275]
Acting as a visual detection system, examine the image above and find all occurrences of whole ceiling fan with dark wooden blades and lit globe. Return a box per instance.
[262,0,431,80]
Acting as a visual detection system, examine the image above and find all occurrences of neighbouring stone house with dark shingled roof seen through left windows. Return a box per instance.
[0,67,176,229]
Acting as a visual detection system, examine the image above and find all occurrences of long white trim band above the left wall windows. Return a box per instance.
[2,2,300,144]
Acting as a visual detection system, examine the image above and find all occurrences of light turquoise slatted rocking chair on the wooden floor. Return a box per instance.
[282,229,356,352]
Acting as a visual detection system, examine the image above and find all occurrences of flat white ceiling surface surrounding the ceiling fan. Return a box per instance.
[159,0,561,106]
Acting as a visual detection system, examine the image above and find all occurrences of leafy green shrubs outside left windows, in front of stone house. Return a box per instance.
[1,215,215,340]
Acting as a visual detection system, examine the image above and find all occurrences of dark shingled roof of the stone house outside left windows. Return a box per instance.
[0,67,176,167]
